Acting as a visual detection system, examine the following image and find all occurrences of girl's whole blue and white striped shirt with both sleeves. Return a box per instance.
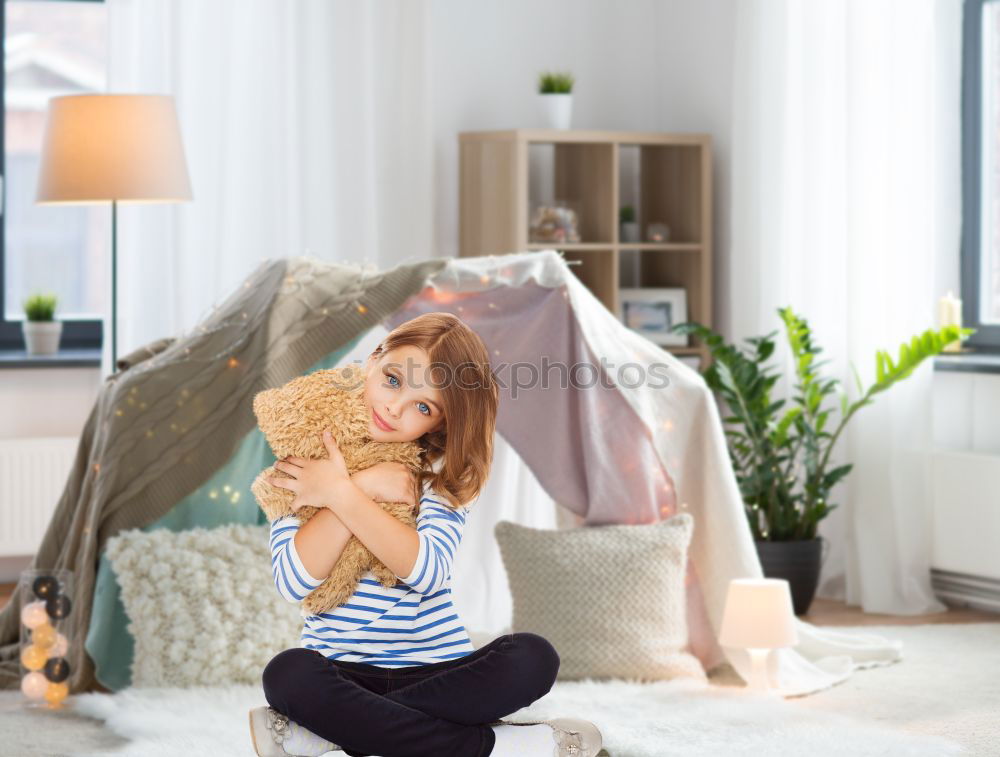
[271,489,475,668]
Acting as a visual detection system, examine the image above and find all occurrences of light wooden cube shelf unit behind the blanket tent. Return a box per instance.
[459,129,712,368]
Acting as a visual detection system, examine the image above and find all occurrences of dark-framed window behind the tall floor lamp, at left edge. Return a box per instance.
[0,0,105,350]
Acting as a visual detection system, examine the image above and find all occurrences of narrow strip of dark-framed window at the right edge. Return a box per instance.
[962,0,1000,349]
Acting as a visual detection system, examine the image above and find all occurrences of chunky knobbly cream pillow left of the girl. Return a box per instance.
[107,524,302,687]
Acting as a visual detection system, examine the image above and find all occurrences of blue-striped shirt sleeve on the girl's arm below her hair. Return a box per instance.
[396,492,469,594]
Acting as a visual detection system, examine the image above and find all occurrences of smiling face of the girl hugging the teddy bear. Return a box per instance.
[364,344,444,442]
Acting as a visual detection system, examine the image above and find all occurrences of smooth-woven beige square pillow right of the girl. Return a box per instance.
[493,513,705,681]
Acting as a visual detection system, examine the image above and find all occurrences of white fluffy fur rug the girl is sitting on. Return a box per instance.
[64,682,959,757]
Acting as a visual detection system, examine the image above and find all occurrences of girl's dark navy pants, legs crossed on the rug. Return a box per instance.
[262,631,559,757]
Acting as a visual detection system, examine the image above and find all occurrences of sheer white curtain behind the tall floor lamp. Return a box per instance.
[104,0,434,374]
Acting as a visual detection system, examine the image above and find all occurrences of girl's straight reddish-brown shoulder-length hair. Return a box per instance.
[372,313,500,507]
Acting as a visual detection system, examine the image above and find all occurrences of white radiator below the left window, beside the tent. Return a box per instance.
[0,436,80,557]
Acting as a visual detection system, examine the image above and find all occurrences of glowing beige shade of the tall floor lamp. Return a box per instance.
[36,95,191,204]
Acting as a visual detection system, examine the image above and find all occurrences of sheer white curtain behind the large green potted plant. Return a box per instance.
[724,0,961,614]
